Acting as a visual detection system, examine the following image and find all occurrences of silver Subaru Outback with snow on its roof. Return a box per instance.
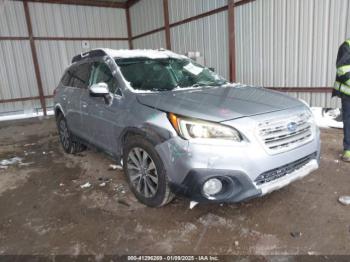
[54,49,320,207]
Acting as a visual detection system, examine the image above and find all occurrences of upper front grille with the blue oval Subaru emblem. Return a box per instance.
[258,111,313,154]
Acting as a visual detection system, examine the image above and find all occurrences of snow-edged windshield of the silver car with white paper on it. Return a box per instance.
[116,58,227,91]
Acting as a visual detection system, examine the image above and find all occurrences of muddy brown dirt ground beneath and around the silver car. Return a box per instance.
[0,118,350,255]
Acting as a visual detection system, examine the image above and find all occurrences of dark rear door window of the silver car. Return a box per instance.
[67,63,91,88]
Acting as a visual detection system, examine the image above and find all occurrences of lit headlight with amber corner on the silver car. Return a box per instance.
[168,113,242,142]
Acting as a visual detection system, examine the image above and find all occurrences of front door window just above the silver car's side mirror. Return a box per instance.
[90,62,120,94]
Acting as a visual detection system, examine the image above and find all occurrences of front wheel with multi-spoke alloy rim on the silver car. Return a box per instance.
[123,136,174,207]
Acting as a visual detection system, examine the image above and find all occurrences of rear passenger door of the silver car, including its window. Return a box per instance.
[65,62,91,139]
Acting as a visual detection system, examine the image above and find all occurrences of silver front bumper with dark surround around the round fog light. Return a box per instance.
[156,108,321,202]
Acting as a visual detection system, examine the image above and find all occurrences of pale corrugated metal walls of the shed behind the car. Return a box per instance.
[0,0,350,114]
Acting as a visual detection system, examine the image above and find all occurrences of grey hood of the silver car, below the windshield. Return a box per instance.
[137,85,303,122]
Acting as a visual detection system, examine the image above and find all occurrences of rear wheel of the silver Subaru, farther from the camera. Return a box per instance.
[56,114,86,154]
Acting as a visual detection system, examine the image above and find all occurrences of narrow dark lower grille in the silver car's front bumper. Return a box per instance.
[254,152,317,186]
